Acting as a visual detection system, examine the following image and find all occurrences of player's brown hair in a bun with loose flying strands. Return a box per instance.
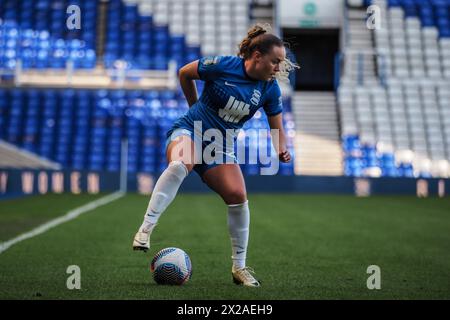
[238,24,300,80]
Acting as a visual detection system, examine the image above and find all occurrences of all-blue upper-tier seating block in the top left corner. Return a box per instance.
[0,0,97,70]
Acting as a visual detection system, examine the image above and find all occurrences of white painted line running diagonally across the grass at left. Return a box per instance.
[0,191,125,254]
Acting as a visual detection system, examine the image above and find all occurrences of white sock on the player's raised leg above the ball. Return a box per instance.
[139,161,189,232]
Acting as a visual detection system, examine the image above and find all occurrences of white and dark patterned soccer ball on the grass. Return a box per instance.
[150,248,192,285]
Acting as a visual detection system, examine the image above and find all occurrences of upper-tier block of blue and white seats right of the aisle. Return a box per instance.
[104,0,249,70]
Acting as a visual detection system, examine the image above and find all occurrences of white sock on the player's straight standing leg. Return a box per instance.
[228,201,250,269]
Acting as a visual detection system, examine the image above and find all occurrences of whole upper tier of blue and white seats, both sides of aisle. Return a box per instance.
[0,0,249,70]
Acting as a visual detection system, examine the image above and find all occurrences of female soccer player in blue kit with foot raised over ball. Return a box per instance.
[133,25,295,287]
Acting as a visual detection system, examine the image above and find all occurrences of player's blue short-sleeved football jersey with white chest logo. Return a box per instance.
[171,56,282,132]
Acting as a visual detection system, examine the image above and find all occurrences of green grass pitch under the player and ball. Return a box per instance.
[0,194,450,300]
